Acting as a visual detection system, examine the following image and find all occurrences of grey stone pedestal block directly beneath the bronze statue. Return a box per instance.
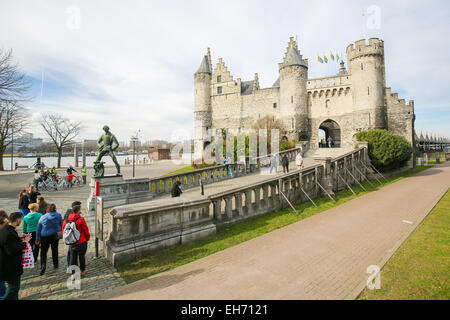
[87,175,128,214]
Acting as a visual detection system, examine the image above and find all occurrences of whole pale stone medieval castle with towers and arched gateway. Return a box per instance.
[194,38,415,156]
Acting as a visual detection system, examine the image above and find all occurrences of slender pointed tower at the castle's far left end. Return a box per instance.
[194,52,212,160]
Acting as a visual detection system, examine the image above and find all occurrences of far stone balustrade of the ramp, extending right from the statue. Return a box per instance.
[87,148,300,213]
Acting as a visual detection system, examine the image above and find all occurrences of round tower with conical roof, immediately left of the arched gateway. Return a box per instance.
[279,37,310,140]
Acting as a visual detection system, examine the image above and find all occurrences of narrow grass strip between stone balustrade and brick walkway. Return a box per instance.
[118,166,431,283]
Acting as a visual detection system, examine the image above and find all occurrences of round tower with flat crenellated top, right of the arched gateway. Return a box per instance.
[347,38,386,130]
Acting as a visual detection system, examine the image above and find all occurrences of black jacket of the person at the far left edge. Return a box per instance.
[0,225,26,281]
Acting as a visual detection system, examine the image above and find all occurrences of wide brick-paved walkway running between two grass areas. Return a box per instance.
[100,162,450,300]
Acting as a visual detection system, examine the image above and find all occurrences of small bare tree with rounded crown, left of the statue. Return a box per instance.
[40,114,82,168]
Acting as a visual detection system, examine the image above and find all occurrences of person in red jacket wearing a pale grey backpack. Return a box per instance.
[62,205,91,277]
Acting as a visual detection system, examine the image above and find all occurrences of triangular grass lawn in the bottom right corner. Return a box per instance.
[359,191,450,300]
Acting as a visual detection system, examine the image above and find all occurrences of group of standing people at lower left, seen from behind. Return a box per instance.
[0,197,90,300]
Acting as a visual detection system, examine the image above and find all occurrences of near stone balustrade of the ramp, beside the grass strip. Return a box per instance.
[105,147,368,266]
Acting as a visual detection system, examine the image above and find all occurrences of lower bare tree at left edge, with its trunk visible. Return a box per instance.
[0,100,27,171]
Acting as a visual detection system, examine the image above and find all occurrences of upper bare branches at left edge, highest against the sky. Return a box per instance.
[0,49,31,103]
